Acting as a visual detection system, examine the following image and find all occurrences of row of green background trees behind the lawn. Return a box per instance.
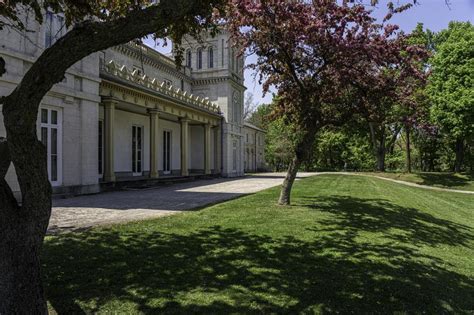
[248,22,474,172]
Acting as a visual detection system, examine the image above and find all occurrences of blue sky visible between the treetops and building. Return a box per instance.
[146,0,474,105]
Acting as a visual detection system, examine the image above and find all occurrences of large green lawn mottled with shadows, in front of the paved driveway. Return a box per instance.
[43,175,474,314]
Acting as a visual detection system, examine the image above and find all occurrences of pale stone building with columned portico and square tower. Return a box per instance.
[0,13,264,198]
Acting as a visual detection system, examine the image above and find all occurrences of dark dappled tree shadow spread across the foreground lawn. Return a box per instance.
[43,197,474,314]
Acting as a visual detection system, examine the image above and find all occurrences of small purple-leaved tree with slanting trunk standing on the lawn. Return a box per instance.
[226,0,426,205]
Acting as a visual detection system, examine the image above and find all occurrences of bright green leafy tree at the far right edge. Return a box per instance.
[427,22,474,172]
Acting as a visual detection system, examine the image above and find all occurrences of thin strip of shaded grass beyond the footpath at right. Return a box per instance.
[369,172,474,191]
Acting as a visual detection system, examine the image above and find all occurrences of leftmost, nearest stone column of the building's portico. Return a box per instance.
[102,98,118,182]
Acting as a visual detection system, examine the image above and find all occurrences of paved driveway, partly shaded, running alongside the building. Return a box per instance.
[48,173,315,233]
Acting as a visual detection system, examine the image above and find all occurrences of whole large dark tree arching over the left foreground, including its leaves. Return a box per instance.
[0,0,225,314]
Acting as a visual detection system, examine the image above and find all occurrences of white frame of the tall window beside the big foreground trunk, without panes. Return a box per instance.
[39,105,63,187]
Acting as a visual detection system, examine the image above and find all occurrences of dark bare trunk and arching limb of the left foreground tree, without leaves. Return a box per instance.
[0,0,220,314]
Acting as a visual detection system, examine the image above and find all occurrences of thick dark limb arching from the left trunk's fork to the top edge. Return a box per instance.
[1,0,219,212]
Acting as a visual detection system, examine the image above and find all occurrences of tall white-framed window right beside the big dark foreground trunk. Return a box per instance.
[41,108,62,186]
